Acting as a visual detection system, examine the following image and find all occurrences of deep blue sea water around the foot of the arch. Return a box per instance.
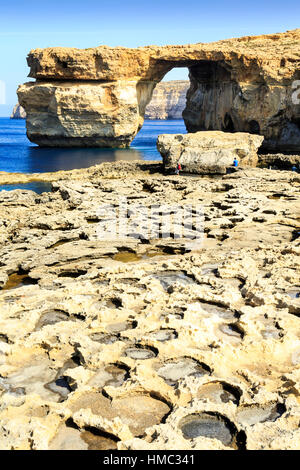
[0,118,186,193]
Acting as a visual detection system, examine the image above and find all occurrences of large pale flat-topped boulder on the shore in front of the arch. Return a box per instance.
[157,131,264,174]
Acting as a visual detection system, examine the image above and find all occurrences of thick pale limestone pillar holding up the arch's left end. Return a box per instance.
[19,80,150,147]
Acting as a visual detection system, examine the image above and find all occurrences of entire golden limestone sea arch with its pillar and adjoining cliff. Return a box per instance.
[18,29,300,152]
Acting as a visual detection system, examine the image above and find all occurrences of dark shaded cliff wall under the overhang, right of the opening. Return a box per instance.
[183,61,300,152]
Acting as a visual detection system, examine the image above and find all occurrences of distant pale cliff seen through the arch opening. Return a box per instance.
[145,80,190,119]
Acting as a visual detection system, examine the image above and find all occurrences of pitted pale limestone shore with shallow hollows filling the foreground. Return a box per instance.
[0,162,300,450]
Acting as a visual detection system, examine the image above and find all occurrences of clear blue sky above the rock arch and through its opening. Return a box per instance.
[0,0,300,116]
